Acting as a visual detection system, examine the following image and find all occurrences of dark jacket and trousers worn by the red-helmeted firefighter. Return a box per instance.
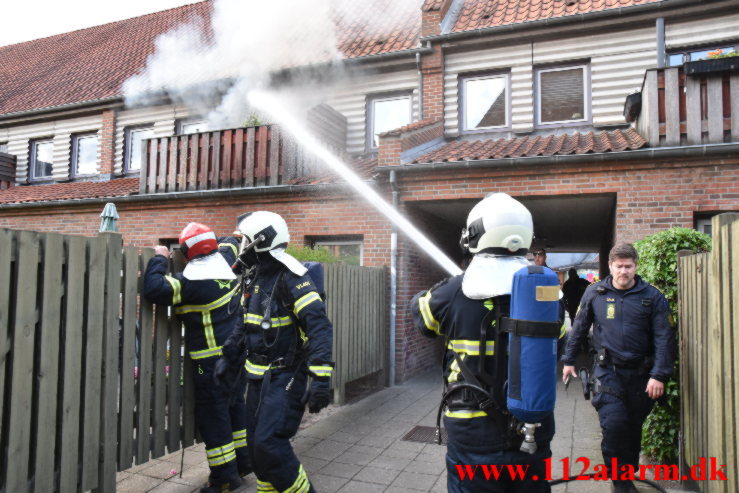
[144,238,249,485]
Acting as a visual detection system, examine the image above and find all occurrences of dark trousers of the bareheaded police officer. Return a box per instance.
[592,366,654,476]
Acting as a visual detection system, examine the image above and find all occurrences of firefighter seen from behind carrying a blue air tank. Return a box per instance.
[411,193,560,493]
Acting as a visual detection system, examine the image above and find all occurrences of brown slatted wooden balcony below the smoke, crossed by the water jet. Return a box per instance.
[139,105,346,194]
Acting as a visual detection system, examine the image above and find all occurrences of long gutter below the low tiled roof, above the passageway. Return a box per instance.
[375,143,739,172]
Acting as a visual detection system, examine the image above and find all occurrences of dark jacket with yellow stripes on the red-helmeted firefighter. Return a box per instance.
[144,238,242,359]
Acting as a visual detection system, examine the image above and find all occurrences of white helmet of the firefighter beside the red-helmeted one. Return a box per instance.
[237,211,307,276]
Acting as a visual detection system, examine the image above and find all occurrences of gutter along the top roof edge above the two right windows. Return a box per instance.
[420,0,702,42]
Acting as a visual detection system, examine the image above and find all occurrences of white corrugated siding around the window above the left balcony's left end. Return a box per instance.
[113,106,190,174]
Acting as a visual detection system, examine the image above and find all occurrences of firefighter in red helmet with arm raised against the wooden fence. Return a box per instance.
[144,223,251,493]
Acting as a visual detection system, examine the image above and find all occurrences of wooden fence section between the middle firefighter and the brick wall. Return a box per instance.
[325,264,387,404]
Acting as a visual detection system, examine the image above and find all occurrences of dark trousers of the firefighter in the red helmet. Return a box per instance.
[193,357,249,485]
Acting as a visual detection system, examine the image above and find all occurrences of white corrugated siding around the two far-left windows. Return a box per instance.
[0,115,102,183]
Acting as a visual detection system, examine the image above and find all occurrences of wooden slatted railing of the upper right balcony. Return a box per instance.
[636,67,739,147]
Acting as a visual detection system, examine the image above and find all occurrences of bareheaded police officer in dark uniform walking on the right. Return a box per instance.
[562,243,675,493]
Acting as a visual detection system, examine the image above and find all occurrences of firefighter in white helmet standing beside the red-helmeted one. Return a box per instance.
[218,211,334,492]
